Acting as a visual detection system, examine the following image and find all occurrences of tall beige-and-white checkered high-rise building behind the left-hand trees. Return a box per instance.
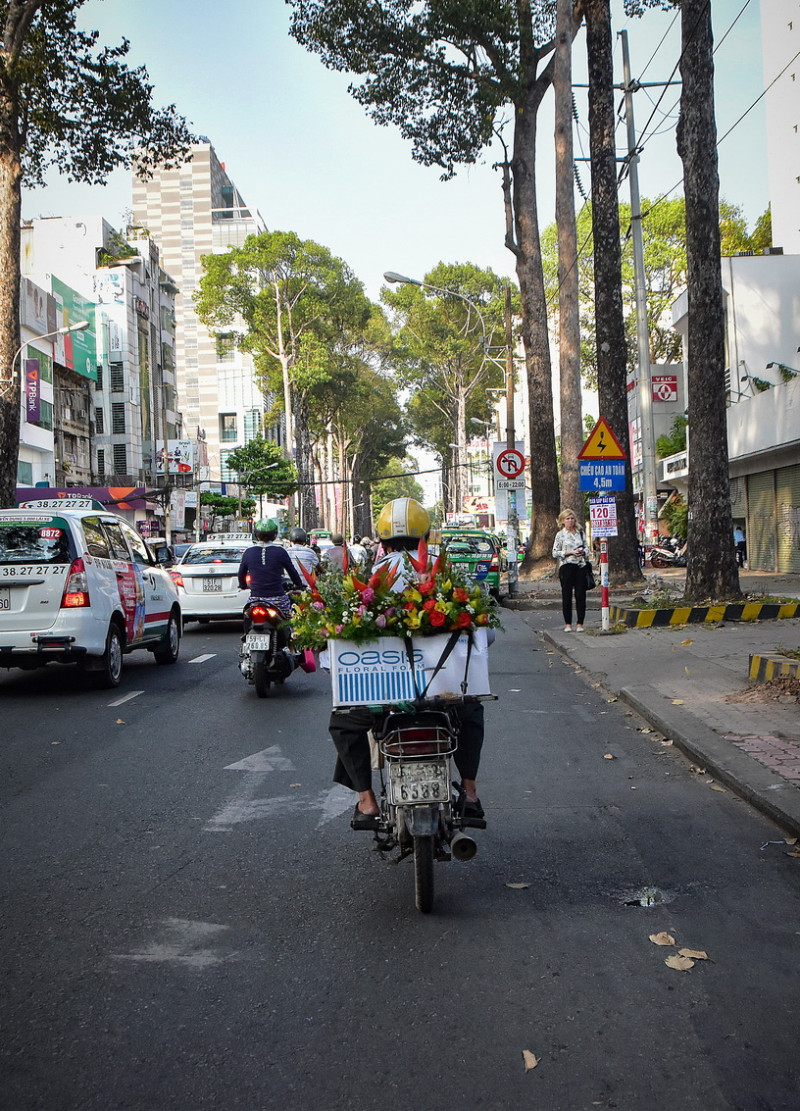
[133,139,279,487]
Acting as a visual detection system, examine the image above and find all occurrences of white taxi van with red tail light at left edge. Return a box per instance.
[0,498,181,687]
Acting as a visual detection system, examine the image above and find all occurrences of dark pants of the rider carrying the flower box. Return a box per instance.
[328,702,483,791]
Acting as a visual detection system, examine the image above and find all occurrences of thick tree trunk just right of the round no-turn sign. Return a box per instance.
[511,77,559,563]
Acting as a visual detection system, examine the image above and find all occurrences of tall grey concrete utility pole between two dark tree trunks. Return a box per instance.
[619,24,658,543]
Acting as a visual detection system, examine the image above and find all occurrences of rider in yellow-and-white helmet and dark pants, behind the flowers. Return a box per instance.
[328,498,483,830]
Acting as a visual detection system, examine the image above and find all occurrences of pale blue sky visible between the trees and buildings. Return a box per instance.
[22,0,769,298]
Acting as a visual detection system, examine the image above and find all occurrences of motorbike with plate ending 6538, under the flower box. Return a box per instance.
[364,695,491,914]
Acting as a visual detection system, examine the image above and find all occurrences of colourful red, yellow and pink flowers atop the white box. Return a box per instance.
[292,541,500,648]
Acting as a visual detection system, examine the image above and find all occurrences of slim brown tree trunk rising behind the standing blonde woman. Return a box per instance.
[553,0,584,512]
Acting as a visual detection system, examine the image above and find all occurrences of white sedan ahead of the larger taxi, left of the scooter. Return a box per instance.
[170,540,250,623]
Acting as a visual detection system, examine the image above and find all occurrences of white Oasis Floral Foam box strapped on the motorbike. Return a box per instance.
[328,629,491,707]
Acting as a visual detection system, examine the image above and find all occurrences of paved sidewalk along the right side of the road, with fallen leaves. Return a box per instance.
[504,571,800,835]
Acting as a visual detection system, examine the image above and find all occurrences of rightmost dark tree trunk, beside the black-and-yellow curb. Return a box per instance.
[678,0,739,602]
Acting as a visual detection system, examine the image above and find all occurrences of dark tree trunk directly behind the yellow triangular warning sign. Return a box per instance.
[576,0,642,583]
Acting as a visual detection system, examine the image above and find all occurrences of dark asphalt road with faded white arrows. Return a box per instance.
[0,613,800,1111]
